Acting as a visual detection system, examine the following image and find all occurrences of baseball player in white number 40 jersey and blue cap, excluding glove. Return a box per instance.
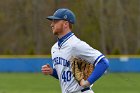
[41,8,109,93]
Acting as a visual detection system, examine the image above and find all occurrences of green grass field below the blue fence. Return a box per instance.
[0,73,140,93]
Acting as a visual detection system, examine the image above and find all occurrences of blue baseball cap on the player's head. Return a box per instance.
[47,8,76,24]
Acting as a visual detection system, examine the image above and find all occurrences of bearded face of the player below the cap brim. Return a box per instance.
[51,20,65,35]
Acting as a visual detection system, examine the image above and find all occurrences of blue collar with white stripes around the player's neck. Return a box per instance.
[58,32,74,47]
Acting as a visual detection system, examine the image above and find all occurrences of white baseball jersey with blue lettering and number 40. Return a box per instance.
[51,33,104,93]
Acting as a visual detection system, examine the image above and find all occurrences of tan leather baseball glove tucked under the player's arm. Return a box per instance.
[71,57,94,82]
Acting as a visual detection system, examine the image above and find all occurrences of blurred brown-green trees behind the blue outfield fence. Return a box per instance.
[0,0,140,55]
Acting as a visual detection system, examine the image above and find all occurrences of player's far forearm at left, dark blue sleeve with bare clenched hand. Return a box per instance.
[41,64,58,79]
